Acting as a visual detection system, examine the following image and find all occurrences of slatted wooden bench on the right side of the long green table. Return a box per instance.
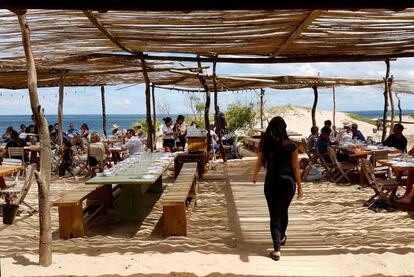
[162,163,197,236]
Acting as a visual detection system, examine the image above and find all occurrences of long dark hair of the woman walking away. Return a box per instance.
[259,116,290,167]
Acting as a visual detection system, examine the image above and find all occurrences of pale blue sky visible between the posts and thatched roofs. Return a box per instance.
[0,58,414,115]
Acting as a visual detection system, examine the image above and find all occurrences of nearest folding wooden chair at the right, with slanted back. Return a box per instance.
[361,159,406,207]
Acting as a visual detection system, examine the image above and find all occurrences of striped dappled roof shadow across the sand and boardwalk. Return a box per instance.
[0,158,414,266]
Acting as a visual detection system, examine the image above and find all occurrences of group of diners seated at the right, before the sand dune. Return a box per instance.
[307,120,408,161]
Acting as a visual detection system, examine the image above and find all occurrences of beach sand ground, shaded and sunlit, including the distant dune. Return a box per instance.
[0,104,414,277]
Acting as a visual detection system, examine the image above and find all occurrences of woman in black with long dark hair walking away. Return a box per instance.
[252,116,303,261]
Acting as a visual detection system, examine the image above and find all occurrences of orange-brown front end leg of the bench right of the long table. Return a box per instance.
[163,203,187,236]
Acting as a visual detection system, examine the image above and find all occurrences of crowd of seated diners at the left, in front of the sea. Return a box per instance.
[0,118,145,179]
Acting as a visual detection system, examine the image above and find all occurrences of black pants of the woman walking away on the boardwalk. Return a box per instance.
[264,174,296,251]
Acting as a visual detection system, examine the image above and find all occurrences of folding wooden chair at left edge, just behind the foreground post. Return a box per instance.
[0,164,36,212]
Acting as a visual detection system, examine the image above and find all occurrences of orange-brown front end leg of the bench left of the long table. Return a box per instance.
[58,203,85,239]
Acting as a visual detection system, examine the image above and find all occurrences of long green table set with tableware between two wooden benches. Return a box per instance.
[85,152,175,221]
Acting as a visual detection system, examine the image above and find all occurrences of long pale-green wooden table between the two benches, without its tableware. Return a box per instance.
[85,153,173,221]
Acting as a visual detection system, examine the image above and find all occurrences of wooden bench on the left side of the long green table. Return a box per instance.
[53,185,117,239]
